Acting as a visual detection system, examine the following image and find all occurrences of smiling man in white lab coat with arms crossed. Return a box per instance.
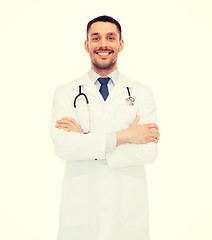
[50,16,160,240]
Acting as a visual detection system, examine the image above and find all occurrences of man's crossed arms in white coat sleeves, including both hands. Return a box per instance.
[49,86,160,168]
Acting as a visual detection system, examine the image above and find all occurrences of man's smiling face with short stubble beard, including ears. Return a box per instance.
[85,22,124,73]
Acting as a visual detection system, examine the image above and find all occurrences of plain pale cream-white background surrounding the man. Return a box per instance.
[0,0,212,240]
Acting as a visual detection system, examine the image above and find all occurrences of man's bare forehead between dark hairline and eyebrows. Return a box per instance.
[88,22,119,35]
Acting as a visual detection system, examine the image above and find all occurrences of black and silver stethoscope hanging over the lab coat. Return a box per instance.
[74,85,135,133]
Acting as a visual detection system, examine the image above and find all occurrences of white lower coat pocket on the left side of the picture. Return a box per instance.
[60,175,88,226]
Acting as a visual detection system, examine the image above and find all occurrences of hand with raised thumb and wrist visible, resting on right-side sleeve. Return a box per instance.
[116,116,160,146]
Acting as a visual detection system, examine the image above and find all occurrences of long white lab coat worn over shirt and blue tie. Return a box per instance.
[50,71,157,240]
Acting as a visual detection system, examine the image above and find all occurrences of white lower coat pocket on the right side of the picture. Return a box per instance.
[119,176,148,228]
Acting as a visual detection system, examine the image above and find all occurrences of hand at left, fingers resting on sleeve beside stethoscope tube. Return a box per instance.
[55,117,83,133]
